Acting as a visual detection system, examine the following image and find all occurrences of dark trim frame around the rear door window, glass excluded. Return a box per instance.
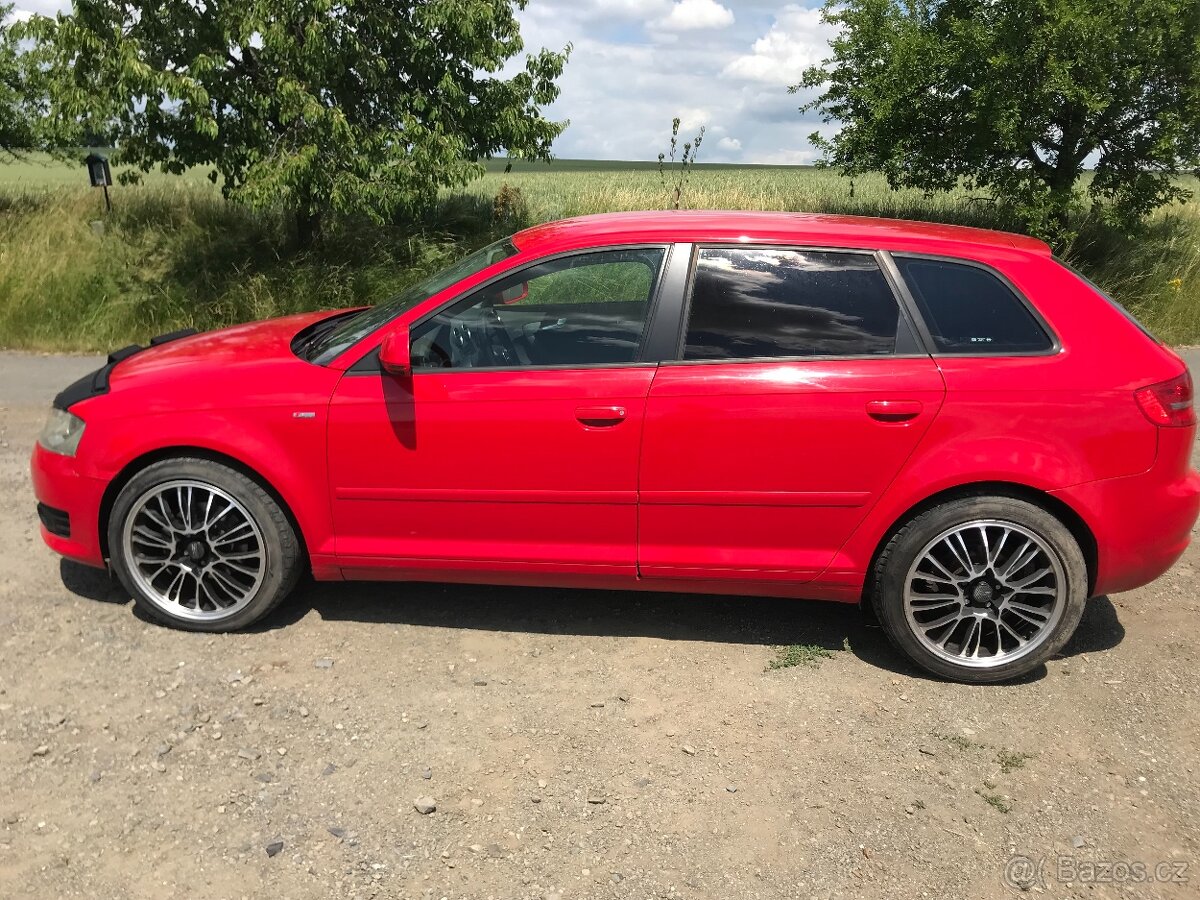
[662,241,930,366]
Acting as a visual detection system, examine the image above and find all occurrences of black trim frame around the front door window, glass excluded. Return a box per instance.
[346,241,688,376]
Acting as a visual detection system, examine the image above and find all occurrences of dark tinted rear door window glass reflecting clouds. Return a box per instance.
[684,247,900,360]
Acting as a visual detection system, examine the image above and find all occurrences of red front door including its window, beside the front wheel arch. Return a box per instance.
[329,246,667,580]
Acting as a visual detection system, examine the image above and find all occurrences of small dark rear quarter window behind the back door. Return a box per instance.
[895,257,1054,355]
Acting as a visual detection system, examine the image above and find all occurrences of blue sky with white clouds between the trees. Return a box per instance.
[14,0,835,164]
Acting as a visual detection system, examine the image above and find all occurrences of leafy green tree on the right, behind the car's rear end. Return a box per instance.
[791,0,1200,236]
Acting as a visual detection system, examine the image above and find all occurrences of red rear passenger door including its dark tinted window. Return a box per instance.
[638,246,944,582]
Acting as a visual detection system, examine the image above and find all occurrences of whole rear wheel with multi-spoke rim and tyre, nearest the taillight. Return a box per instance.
[870,497,1087,684]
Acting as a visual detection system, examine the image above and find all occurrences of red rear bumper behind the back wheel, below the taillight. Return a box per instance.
[1051,446,1200,595]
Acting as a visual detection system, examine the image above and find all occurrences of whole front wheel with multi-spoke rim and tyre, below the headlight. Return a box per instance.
[107,458,304,631]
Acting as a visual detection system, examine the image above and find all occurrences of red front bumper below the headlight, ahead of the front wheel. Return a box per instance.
[30,444,104,568]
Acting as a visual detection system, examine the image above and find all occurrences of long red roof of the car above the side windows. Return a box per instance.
[512,210,1050,256]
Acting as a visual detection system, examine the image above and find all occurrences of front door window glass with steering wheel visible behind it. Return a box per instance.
[413,247,666,370]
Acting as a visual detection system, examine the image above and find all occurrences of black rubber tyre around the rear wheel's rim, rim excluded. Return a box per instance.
[874,497,1087,684]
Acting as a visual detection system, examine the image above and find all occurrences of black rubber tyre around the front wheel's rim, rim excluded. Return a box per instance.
[108,460,295,631]
